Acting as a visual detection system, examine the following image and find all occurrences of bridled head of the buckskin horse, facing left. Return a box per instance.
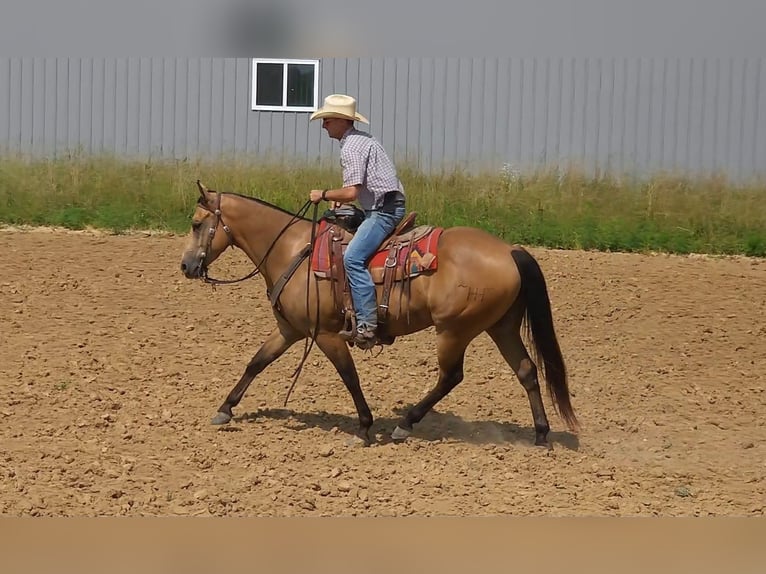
[181,181,231,279]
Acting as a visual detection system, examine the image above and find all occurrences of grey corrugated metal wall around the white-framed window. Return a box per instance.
[0,58,766,178]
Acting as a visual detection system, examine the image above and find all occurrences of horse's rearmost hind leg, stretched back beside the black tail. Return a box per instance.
[487,320,550,447]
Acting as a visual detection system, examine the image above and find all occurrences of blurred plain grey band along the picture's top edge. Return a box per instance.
[0,0,766,58]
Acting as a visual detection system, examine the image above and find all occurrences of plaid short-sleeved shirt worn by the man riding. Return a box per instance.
[340,128,404,209]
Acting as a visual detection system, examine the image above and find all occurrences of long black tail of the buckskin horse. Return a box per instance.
[511,246,579,431]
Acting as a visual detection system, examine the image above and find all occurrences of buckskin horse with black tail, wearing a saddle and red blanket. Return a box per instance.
[181,181,579,448]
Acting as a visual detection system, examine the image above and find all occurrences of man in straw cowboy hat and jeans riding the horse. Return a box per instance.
[309,94,412,349]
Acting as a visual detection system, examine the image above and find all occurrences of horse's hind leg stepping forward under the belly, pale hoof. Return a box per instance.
[391,331,468,442]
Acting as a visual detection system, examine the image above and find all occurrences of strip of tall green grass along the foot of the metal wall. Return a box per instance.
[0,155,766,257]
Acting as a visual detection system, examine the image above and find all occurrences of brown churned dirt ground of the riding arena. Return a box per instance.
[0,230,766,516]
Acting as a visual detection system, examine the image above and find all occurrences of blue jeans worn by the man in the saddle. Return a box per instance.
[343,206,406,329]
